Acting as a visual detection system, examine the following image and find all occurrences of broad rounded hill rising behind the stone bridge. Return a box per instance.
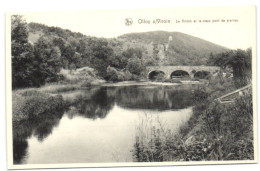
[118,31,228,65]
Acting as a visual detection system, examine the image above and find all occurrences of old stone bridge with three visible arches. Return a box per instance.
[146,66,220,79]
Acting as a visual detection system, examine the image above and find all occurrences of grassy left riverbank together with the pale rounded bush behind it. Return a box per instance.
[12,67,107,121]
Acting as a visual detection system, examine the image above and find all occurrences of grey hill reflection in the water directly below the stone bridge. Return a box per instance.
[112,86,192,110]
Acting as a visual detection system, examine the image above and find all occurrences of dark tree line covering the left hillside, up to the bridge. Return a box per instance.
[11,15,143,88]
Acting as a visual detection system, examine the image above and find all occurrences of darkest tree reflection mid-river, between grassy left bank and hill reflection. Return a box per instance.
[70,88,114,119]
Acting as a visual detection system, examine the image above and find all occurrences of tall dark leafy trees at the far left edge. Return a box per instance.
[11,15,64,88]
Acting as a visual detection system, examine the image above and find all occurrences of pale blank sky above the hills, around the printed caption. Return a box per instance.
[20,7,255,49]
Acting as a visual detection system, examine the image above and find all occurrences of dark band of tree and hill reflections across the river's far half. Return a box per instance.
[68,86,195,119]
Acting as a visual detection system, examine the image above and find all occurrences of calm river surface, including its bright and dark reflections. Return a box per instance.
[13,84,199,164]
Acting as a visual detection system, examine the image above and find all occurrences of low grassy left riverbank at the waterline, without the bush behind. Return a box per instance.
[12,83,97,121]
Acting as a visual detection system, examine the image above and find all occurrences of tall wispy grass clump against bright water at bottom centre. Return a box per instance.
[133,115,180,162]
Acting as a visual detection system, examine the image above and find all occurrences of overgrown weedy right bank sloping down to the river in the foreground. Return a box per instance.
[133,77,254,162]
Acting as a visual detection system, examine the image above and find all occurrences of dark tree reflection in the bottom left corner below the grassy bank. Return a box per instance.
[13,109,64,164]
